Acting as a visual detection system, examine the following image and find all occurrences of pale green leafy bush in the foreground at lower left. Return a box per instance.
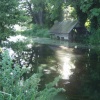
[0,51,63,100]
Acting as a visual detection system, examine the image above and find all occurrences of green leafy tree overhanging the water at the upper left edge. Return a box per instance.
[0,0,25,42]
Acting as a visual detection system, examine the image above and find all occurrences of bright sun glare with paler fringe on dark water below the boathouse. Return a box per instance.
[51,46,81,80]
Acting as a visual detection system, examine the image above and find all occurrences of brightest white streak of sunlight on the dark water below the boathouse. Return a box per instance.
[56,47,75,80]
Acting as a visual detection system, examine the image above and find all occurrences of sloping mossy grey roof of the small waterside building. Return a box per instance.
[50,19,78,34]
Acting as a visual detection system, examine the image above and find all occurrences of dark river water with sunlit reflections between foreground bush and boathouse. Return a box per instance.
[4,35,100,100]
